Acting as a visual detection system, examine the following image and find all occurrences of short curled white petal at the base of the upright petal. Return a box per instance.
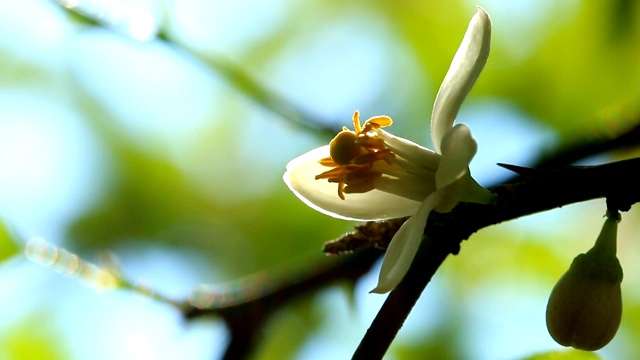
[436,124,478,189]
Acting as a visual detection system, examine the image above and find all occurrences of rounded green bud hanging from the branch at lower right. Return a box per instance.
[547,214,622,351]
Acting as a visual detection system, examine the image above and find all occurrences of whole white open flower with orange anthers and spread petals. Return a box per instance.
[284,7,493,293]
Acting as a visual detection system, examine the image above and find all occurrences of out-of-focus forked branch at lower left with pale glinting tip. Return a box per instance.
[25,235,380,359]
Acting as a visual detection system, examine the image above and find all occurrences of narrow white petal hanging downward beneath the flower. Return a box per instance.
[370,192,442,294]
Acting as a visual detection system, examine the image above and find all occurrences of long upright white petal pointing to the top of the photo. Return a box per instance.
[431,6,491,153]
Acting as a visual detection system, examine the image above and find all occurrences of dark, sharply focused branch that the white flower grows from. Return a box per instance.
[353,158,640,359]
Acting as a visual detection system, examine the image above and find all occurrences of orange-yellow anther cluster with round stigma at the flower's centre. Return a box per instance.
[315,110,395,200]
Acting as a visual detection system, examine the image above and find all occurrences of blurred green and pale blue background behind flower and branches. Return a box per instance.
[0,0,640,359]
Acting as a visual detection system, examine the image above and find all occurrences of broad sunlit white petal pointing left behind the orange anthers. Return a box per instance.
[283,145,420,221]
